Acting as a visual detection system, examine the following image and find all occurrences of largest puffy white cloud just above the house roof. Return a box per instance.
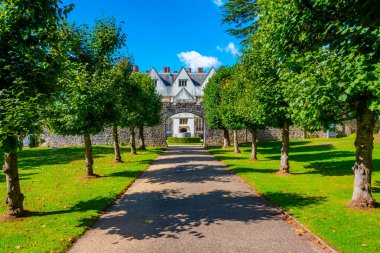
[177,51,222,69]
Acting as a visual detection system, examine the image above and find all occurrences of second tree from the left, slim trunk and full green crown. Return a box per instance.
[50,18,125,176]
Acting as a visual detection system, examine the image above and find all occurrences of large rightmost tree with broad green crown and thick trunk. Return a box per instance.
[268,0,380,208]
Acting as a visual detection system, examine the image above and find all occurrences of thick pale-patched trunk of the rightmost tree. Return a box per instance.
[351,103,376,208]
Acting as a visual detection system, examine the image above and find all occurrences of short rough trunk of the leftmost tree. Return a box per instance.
[3,141,24,216]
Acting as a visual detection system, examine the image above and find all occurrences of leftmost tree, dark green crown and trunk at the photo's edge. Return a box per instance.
[0,0,71,216]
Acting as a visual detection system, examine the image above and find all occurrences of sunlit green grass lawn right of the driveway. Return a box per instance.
[209,136,380,253]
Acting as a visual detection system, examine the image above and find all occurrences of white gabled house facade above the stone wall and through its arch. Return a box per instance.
[149,67,216,137]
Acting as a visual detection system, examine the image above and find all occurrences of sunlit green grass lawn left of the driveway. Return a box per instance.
[0,146,162,252]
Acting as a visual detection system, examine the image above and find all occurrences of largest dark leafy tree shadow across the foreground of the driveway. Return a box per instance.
[84,190,322,240]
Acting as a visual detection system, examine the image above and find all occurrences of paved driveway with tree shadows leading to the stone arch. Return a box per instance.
[70,146,323,253]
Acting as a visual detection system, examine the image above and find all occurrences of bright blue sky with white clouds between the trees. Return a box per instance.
[64,0,239,72]
